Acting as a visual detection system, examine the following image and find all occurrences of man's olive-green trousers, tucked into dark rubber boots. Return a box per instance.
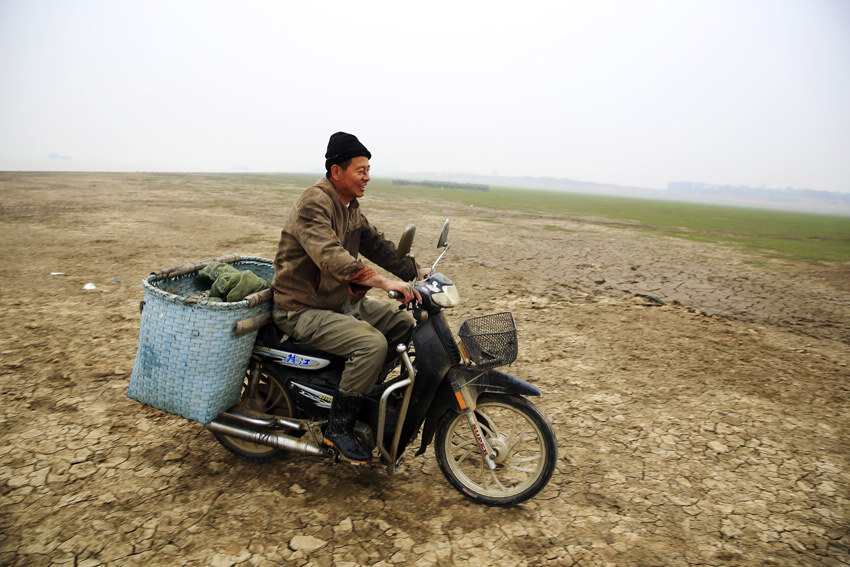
[273,297,414,396]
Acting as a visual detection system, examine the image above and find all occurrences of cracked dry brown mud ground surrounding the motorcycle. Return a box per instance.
[0,173,850,567]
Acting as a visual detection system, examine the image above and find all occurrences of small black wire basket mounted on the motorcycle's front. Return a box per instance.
[458,312,517,368]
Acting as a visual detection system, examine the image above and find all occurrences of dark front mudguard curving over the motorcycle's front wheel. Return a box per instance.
[416,367,542,457]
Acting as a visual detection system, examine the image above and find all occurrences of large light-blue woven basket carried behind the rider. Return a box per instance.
[127,256,274,423]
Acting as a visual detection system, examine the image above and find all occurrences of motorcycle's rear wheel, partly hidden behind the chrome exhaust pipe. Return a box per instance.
[213,362,295,462]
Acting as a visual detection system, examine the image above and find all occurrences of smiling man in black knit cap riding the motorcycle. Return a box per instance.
[272,132,420,463]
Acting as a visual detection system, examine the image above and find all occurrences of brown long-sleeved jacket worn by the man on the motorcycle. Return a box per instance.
[272,177,416,312]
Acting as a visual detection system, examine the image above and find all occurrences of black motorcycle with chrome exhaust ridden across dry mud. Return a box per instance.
[206,219,558,506]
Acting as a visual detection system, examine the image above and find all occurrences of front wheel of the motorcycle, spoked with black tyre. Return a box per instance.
[434,394,558,506]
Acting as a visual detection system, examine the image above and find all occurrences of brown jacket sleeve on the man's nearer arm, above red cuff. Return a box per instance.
[294,195,363,282]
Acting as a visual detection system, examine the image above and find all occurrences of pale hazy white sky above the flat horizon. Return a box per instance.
[0,0,850,191]
